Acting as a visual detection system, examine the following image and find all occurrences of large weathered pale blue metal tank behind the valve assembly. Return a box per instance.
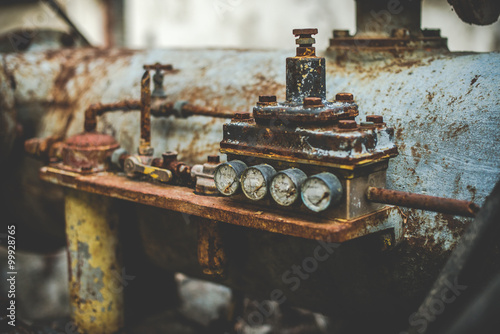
[0,1,500,331]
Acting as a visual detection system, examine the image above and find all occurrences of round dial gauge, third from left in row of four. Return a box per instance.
[270,168,307,206]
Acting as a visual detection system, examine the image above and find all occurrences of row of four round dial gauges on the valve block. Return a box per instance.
[214,160,342,212]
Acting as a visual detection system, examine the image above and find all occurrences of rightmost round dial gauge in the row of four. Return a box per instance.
[301,173,343,212]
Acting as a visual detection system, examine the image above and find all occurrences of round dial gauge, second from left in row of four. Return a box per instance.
[241,164,276,201]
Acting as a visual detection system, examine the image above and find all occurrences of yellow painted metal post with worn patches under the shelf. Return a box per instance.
[65,189,124,334]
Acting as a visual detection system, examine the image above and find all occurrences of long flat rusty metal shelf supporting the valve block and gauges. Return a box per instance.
[40,167,402,242]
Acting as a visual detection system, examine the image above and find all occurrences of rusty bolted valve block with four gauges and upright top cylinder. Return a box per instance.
[215,29,398,219]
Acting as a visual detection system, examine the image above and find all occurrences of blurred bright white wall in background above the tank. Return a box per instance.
[122,0,500,52]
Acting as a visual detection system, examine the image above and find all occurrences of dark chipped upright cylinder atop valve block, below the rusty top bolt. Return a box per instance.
[286,56,326,103]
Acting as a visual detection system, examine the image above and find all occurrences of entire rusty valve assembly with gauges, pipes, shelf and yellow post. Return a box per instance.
[20,29,488,333]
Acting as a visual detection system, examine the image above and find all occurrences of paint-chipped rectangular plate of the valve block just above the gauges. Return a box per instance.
[220,119,398,169]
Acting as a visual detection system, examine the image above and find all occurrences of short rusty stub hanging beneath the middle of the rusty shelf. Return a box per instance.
[195,217,227,277]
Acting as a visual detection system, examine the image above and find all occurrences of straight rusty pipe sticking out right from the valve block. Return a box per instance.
[366,187,479,217]
